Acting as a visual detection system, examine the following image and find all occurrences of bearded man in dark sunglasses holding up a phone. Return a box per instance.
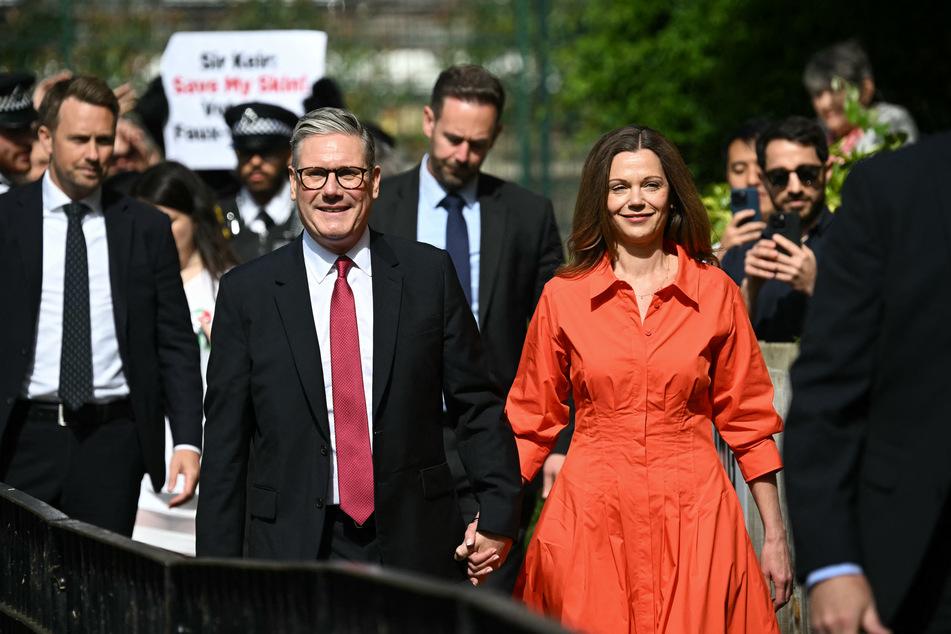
[740,116,832,341]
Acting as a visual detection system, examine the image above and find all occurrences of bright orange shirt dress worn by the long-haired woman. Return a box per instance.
[506,242,782,634]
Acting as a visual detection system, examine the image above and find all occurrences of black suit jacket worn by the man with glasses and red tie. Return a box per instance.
[197,232,521,579]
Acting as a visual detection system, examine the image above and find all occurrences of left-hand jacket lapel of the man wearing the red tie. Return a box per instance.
[274,237,330,440]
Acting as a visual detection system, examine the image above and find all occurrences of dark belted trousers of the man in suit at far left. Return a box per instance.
[0,404,145,536]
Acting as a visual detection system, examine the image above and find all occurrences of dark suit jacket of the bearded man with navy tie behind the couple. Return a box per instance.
[370,165,564,392]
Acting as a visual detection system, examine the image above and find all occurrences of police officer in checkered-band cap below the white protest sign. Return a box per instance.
[219,102,303,262]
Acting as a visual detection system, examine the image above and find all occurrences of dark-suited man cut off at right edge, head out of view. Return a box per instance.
[784,133,951,632]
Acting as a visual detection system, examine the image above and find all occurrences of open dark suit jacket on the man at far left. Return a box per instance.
[0,181,202,489]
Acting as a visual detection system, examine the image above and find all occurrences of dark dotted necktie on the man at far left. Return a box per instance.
[59,203,92,411]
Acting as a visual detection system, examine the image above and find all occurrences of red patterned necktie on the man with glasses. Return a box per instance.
[330,255,373,524]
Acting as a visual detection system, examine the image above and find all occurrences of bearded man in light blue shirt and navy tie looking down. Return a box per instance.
[372,65,570,593]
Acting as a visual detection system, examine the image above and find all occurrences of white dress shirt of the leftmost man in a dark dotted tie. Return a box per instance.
[21,170,129,403]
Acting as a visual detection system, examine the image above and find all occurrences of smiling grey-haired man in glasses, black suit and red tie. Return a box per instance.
[197,108,521,579]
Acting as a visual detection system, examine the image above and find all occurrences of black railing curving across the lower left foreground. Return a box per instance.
[0,484,565,634]
